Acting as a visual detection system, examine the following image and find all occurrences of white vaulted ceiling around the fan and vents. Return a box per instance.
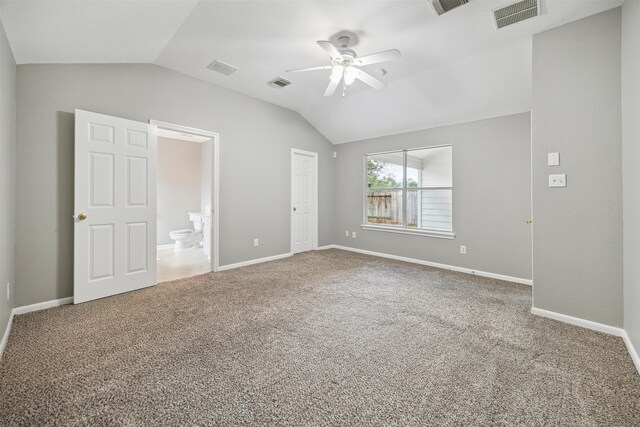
[0,0,623,143]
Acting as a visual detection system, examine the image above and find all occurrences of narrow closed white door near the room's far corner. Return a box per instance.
[291,149,318,254]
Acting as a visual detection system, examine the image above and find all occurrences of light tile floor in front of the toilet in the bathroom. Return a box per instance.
[157,248,211,283]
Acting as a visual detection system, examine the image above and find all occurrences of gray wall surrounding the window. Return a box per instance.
[333,113,531,279]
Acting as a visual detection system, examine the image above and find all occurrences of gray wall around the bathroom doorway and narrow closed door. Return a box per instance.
[15,64,333,306]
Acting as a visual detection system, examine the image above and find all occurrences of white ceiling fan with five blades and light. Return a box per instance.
[287,36,401,96]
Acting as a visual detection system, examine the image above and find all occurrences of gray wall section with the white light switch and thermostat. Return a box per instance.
[532,8,624,327]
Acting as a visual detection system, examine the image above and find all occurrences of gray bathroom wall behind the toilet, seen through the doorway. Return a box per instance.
[157,138,201,245]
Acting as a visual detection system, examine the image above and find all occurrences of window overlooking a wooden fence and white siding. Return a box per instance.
[363,146,454,238]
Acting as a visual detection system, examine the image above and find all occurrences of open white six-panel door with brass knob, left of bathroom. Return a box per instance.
[73,110,157,304]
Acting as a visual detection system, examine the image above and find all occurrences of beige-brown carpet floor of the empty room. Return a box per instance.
[0,250,640,426]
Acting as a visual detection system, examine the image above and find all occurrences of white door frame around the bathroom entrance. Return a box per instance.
[149,119,220,272]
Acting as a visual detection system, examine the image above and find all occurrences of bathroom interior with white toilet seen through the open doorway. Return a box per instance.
[157,129,213,283]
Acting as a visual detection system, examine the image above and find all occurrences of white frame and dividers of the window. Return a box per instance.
[360,144,456,239]
